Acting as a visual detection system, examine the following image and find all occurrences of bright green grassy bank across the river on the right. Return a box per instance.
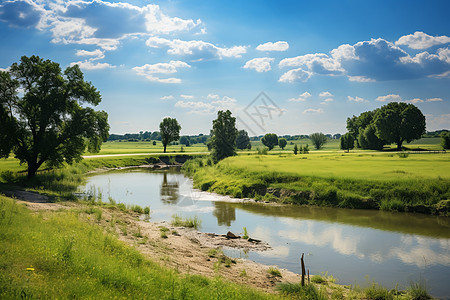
[183,153,450,216]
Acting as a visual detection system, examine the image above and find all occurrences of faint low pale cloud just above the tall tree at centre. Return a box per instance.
[175,94,237,114]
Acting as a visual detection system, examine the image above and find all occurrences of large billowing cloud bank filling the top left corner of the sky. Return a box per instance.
[0,0,203,50]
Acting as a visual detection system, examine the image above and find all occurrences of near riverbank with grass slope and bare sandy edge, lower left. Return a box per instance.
[0,194,366,299]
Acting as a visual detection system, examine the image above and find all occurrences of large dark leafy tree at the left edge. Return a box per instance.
[0,56,109,177]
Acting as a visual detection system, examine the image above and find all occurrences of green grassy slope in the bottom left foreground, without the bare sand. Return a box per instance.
[0,196,277,299]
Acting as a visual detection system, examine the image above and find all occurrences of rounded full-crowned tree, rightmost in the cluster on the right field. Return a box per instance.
[374,102,426,150]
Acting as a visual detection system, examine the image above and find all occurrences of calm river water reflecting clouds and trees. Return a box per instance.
[83,170,450,298]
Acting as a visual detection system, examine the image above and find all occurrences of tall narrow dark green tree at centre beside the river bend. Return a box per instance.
[208,110,238,162]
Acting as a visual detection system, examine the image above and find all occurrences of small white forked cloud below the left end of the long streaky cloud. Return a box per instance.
[133,60,191,83]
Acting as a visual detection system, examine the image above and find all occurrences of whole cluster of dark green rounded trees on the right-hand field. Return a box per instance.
[341,102,425,150]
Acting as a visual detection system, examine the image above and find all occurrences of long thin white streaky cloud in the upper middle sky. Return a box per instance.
[145,37,247,60]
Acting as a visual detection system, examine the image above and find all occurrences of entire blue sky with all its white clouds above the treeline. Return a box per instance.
[0,0,450,135]
